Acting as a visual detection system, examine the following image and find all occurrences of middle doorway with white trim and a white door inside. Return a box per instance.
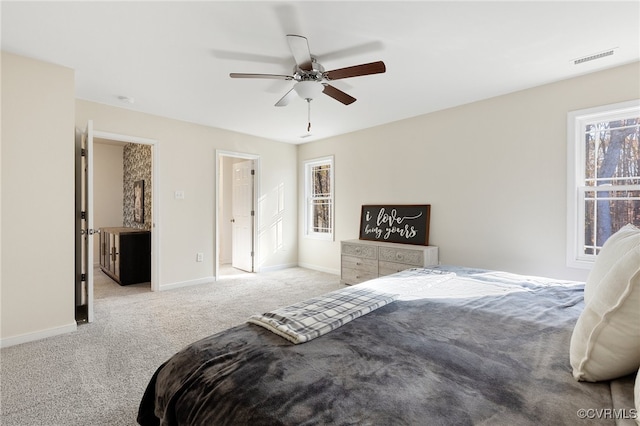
[215,151,259,279]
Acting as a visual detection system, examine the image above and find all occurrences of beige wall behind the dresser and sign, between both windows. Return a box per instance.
[298,59,640,280]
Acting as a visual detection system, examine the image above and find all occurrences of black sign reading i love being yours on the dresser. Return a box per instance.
[360,204,431,246]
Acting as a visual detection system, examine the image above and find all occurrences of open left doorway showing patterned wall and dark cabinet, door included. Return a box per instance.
[75,120,159,323]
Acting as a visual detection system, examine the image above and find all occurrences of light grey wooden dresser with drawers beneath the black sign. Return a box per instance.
[340,240,438,285]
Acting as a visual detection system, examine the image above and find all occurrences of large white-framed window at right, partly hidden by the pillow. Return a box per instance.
[567,101,640,267]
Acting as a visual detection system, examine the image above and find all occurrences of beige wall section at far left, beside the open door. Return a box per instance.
[0,52,76,345]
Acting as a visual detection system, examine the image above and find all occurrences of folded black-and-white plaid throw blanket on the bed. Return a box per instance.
[247,286,397,344]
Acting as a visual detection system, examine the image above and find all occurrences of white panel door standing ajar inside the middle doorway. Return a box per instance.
[231,160,255,272]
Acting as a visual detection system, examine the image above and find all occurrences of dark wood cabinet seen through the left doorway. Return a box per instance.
[100,228,151,285]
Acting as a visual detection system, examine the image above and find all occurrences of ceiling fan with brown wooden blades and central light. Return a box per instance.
[229,34,386,131]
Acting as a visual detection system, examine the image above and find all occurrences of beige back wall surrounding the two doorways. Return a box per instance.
[76,100,297,289]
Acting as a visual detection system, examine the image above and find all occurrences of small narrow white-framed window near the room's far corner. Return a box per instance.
[304,157,333,240]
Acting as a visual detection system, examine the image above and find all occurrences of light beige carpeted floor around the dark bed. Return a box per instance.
[0,268,343,426]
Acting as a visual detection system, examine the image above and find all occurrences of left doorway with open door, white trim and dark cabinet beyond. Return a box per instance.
[76,122,159,322]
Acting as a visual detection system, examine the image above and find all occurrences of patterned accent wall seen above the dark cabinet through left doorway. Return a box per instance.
[122,143,152,231]
